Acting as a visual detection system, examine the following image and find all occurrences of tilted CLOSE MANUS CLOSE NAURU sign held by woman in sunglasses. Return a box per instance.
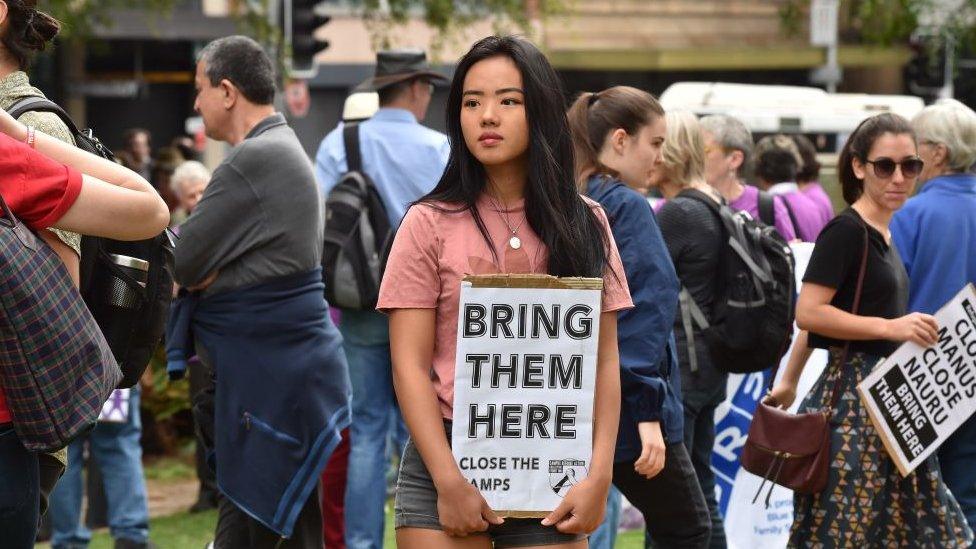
[857,284,976,476]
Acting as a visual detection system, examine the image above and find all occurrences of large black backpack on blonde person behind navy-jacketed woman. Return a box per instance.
[679,190,796,373]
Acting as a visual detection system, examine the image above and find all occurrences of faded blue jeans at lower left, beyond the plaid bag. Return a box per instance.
[50,387,149,549]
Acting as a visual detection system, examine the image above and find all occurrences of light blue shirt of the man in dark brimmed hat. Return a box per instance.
[315,108,451,227]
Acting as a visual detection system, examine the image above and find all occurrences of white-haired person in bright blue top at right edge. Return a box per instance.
[891,99,976,536]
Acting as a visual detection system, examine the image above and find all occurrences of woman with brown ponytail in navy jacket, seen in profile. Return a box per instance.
[569,86,711,547]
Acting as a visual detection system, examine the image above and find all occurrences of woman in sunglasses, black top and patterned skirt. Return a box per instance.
[767,114,973,547]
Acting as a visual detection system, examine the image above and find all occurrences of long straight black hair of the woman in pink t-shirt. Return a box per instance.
[418,36,608,277]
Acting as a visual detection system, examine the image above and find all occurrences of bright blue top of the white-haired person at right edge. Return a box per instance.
[891,174,976,314]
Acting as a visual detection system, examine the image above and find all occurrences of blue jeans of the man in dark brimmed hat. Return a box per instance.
[339,310,406,549]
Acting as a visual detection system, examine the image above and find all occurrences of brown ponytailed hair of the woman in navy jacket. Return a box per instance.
[568,86,664,186]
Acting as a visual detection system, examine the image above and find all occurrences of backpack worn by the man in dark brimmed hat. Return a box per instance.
[322,124,395,310]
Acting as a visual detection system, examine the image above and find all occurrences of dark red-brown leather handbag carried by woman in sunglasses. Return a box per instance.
[740,219,869,507]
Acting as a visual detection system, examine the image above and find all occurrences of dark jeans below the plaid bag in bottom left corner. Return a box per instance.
[0,423,40,549]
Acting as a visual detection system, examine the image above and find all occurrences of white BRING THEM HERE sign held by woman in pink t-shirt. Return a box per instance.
[451,275,603,517]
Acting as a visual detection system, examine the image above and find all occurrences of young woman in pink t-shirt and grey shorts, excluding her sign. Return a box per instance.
[377,36,631,549]
